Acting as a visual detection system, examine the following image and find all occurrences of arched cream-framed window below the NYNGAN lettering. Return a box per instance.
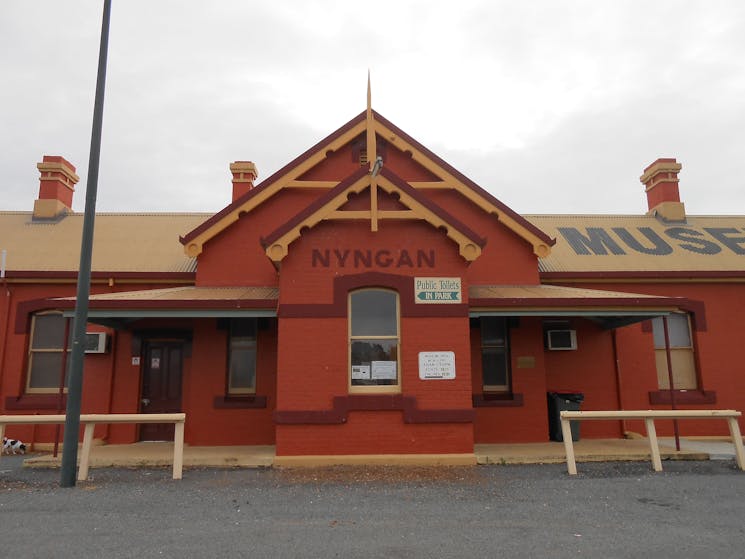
[349,289,401,392]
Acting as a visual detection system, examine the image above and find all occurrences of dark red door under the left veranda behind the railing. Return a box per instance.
[140,340,183,441]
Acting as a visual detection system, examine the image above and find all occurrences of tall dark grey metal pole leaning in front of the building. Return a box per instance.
[60,0,111,487]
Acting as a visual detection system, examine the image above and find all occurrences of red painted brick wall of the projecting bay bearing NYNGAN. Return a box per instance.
[276,218,473,455]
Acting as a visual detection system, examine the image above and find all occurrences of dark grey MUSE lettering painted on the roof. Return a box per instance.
[558,227,745,256]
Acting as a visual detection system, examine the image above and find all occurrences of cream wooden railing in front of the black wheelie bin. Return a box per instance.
[561,410,745,475]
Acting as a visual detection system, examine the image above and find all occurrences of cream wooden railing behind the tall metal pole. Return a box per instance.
[0,413,186,481]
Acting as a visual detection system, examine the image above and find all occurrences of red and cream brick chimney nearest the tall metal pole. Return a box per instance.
[33,155,80,219]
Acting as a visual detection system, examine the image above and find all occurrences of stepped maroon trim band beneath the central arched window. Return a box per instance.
[274,394,475,425]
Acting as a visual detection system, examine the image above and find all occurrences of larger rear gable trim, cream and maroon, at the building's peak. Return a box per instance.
[180,107,555,257]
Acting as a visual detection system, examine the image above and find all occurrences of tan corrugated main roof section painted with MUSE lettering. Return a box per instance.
[525,215,745,272]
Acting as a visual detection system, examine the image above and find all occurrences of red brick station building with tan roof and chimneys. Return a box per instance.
[0,100,745,464]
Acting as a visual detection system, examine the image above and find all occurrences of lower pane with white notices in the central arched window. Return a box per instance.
[352,340,398,386]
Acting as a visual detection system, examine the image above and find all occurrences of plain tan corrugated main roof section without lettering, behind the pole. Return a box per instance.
[0,212,211,272]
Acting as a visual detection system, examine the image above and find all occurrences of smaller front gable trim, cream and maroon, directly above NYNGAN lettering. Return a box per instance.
[262,167,486,264]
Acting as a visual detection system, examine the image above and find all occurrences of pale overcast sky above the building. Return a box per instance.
[0,0,745,214]
